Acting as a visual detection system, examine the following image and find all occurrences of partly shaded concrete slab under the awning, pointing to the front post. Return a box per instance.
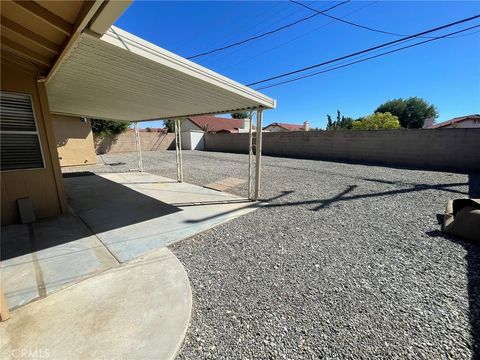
[65,172,256,262]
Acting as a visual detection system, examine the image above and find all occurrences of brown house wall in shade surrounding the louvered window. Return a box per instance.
[0,58,67,225]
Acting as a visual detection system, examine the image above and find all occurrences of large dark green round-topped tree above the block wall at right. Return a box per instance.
[375,97,438,129]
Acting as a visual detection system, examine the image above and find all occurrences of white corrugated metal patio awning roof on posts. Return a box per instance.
[47,26,275,121]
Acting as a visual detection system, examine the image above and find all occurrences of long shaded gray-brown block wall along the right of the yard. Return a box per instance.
[205,129,480,172]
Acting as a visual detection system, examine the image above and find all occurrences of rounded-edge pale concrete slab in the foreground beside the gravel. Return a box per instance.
[0,248,192,360]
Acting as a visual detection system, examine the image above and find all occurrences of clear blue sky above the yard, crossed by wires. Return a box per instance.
[115,1,480,127]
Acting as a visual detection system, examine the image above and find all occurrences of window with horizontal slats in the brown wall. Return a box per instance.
[0,91,45,171]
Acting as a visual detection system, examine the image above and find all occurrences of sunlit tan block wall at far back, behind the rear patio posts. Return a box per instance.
[95,130,175,154]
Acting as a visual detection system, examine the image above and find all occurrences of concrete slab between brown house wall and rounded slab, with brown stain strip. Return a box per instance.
[0,215,118,309]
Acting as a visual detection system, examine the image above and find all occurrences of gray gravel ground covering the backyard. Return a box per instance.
[64,152,480,359]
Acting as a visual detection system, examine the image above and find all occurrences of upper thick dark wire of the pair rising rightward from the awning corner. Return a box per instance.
[247,15,480,86]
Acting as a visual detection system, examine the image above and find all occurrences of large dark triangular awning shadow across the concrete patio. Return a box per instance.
[1,172,182,261]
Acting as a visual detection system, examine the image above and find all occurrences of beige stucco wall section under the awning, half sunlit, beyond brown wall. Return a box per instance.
[52,115,97,166]
